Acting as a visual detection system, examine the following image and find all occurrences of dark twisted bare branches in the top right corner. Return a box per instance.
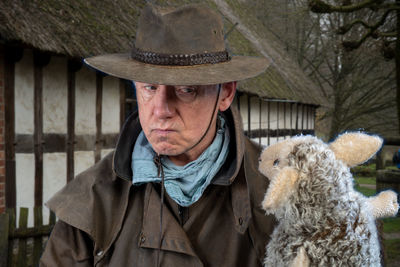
[309,0,400,133]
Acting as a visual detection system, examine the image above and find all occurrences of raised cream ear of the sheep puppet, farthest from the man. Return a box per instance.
[329,133,383,167]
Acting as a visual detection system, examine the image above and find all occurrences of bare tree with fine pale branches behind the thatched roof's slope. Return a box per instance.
[252,0,397,138]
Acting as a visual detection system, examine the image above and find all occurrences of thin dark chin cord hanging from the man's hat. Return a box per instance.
[153,84,222,267]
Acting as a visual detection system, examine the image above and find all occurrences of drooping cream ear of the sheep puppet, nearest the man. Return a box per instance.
[261,167,299,213]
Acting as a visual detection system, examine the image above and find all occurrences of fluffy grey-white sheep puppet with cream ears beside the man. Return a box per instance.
[259,132,399,266]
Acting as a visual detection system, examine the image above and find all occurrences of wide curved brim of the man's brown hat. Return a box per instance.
[85,54,270,85]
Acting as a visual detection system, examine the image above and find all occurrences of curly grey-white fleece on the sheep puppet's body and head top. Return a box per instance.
[264,136,381,266]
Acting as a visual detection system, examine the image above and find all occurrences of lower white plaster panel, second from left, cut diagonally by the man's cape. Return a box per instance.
[43,153,67,224]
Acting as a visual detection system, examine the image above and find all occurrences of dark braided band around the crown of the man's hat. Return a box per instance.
[131,47,231,66]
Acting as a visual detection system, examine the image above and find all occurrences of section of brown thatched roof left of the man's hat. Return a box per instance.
[0,0,145,57]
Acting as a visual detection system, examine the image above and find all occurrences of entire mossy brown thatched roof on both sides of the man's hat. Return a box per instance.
[0,0,325,105]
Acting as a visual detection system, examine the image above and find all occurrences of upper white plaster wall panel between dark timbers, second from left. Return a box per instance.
[43,56,68,133]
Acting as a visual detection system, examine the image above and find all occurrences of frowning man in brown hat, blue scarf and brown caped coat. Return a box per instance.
[41,5,274,266]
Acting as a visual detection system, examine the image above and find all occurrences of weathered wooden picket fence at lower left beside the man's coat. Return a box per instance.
[0,207,56,267]
